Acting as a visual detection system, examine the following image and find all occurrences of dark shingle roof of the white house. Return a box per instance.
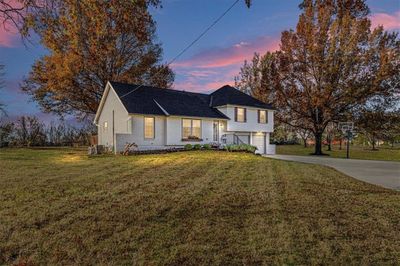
[110,81,272,119]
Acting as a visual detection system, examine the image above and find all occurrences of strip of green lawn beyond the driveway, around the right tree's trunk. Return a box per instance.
[276,145,400,161]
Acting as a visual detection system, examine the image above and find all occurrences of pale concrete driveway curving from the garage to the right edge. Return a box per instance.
[265,155,400,191]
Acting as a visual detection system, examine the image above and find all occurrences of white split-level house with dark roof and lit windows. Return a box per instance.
[94,82,275,154]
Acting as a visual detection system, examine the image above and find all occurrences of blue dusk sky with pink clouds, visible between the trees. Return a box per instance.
[0,0,400,121]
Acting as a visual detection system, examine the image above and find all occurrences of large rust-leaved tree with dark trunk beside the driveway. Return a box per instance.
[236,0,400,154]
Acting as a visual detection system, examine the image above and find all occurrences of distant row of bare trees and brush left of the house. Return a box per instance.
[0,116,96,148]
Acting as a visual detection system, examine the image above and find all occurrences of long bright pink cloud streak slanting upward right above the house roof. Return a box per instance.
[172,36,280,68]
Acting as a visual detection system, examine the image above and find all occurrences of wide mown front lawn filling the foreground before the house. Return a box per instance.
[0,149,400,265]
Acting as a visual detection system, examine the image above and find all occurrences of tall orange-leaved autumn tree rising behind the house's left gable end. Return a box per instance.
[23,0,173,117]
